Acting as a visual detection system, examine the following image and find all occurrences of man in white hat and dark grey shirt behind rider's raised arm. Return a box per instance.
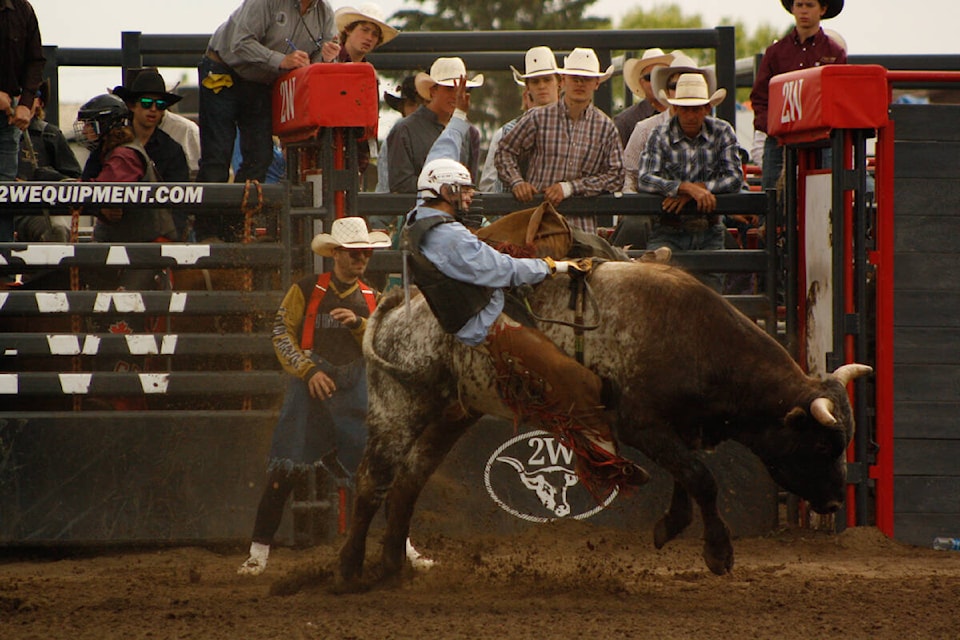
[387,58,483,193]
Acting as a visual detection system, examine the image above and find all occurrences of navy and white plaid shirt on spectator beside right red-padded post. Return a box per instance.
[637,116,743,197]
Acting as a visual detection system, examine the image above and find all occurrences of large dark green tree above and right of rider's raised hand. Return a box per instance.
[388,0,610,140]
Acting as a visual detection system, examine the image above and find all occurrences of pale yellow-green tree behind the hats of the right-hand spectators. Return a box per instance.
[618,4,791,102]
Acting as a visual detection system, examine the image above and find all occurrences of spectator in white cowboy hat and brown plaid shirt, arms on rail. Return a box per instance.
[494,47,623,232]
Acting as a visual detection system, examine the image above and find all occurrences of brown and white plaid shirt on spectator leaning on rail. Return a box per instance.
[495,100,624,196]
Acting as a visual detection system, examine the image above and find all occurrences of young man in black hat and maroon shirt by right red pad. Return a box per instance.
[750,0,847,189]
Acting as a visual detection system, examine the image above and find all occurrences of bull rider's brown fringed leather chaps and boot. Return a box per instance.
[483,313,650,500]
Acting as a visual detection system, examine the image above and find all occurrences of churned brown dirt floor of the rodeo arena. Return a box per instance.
[0,522,960,640]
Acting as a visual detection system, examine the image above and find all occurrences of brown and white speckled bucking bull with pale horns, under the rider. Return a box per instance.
[340,262,871,587]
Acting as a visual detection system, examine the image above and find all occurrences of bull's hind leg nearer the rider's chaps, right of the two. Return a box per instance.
[380,405,480,579]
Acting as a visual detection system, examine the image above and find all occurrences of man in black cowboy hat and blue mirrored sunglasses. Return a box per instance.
[113,68,190,241]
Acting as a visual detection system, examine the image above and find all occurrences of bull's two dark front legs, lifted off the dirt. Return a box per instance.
[636,430,733,575]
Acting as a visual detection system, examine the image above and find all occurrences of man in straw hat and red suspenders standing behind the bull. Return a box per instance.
[237,217,404,576]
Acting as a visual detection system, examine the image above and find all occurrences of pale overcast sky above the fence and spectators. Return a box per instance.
[31,0,960,103]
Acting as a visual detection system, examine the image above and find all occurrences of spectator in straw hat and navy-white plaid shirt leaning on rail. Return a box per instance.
[638,73,743,292]
